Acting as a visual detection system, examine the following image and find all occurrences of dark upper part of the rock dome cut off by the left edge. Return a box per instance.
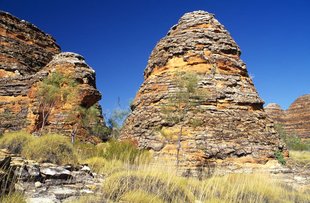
[0,11,60,78]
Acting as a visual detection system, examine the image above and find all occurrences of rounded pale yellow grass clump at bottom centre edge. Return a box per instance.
[103,171,195,202]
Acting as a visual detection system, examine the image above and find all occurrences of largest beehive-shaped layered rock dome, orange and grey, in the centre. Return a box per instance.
[121,11,283,173]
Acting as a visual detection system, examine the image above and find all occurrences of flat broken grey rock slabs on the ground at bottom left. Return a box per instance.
[0,150,103,203]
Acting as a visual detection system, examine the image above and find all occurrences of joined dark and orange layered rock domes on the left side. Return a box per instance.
[0,11,103,141]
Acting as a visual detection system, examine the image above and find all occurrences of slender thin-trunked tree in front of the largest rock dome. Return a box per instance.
[161,72,205,168]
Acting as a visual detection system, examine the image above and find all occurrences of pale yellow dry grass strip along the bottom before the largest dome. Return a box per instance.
[102,165,310,202]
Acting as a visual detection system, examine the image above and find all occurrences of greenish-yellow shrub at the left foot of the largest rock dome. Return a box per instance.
[97,140,149,163]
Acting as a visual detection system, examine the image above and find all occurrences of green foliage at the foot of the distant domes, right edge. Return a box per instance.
[275,124,310,151]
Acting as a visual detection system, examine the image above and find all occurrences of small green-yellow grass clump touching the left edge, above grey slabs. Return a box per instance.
[0,131,33,153]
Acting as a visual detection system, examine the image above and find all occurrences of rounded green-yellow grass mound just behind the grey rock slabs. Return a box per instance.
[22,134,76,164]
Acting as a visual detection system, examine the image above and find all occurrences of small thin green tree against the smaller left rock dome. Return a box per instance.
[36,72,76,131]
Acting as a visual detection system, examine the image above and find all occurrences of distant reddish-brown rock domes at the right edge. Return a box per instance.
[265,94,310,138]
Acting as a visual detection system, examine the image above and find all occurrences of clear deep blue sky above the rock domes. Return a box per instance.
[0,0,310,112]
